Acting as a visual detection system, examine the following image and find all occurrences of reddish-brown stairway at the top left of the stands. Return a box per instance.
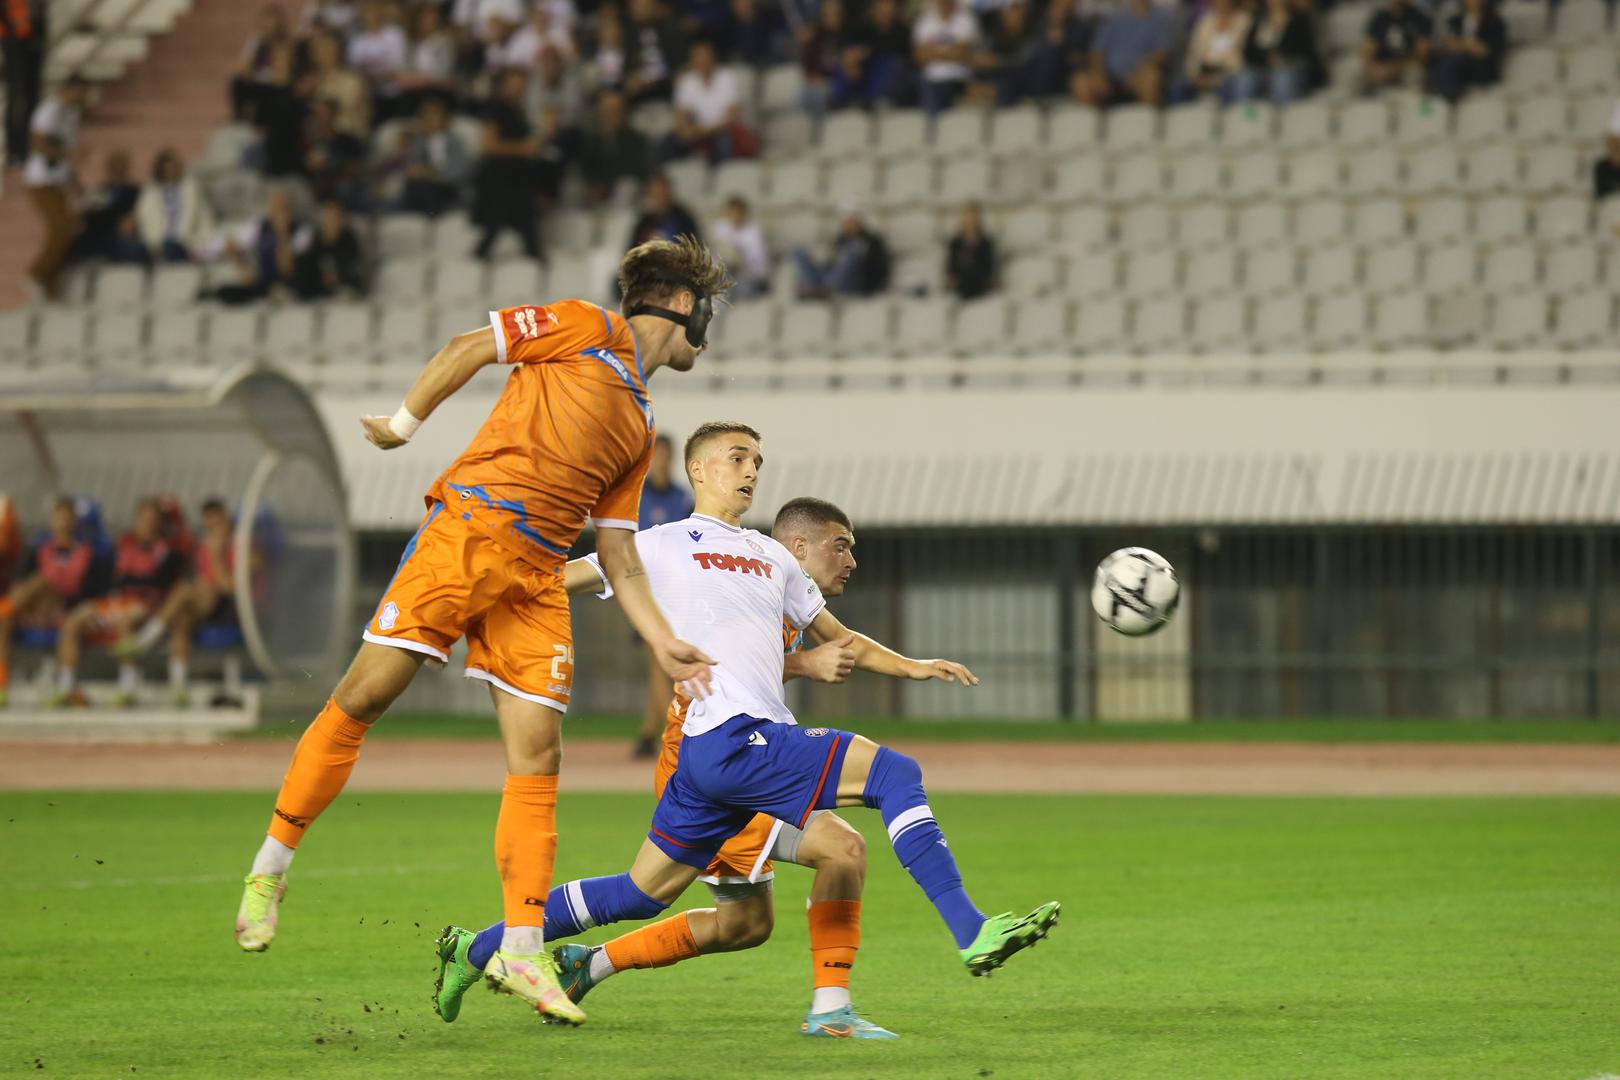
[0,0,303,311]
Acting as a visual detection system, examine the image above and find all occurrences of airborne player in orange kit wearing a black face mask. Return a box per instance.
[237,236,731,1023]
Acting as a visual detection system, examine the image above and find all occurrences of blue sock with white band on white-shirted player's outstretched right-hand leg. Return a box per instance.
[863,746,985,949]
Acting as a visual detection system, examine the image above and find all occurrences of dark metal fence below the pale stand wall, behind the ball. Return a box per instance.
[363,526,1620,721]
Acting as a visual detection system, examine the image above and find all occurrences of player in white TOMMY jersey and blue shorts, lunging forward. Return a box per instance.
[441,423,1058,1038]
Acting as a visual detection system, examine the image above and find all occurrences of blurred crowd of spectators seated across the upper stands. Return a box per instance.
[15,0,1620,301]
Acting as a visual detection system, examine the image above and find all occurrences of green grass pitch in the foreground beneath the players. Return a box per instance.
[0,792,1620,1080]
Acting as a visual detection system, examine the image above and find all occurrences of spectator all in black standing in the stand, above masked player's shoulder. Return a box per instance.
[473,68,546,261]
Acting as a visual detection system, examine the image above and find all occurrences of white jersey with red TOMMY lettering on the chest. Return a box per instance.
[588,513,826,735]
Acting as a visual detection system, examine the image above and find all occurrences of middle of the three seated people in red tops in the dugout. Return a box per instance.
[52,499,183,706]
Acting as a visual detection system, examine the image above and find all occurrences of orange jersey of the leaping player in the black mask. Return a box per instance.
[428,300,653,568]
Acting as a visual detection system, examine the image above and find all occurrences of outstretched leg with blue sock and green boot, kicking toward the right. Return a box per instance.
[838,735,1058,975]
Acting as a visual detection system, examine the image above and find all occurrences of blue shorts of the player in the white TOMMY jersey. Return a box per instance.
[646,716,855,870]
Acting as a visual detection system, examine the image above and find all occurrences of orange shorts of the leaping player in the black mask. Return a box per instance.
[363,504,573,712]
